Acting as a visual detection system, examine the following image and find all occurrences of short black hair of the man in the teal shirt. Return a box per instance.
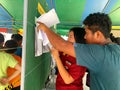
[83,12,112,38]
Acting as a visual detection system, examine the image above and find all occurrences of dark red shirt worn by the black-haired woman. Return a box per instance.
[56,53,86,90]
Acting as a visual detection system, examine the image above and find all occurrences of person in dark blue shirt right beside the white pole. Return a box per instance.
[11,34,23,57]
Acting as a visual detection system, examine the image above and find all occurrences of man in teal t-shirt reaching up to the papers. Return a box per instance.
[37,12,120,90]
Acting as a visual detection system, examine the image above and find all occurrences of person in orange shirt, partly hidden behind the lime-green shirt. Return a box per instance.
[4,40,21,90]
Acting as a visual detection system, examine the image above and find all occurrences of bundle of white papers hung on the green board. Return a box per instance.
[35,9,60,56]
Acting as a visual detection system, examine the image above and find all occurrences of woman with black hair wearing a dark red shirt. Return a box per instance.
[51,27,86,90]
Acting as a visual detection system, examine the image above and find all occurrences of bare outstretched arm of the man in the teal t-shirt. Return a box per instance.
[37,22,75,57]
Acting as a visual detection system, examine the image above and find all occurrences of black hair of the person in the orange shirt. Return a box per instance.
[4,40,18,53]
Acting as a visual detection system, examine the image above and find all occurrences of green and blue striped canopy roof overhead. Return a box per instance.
[0,0,120,32]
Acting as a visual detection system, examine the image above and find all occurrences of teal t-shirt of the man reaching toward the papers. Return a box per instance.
[75,44,120,90]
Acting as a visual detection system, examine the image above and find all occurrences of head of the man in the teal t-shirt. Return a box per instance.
[83,13,112,43]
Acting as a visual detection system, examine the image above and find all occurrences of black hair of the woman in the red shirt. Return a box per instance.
[69,27,85,44]
